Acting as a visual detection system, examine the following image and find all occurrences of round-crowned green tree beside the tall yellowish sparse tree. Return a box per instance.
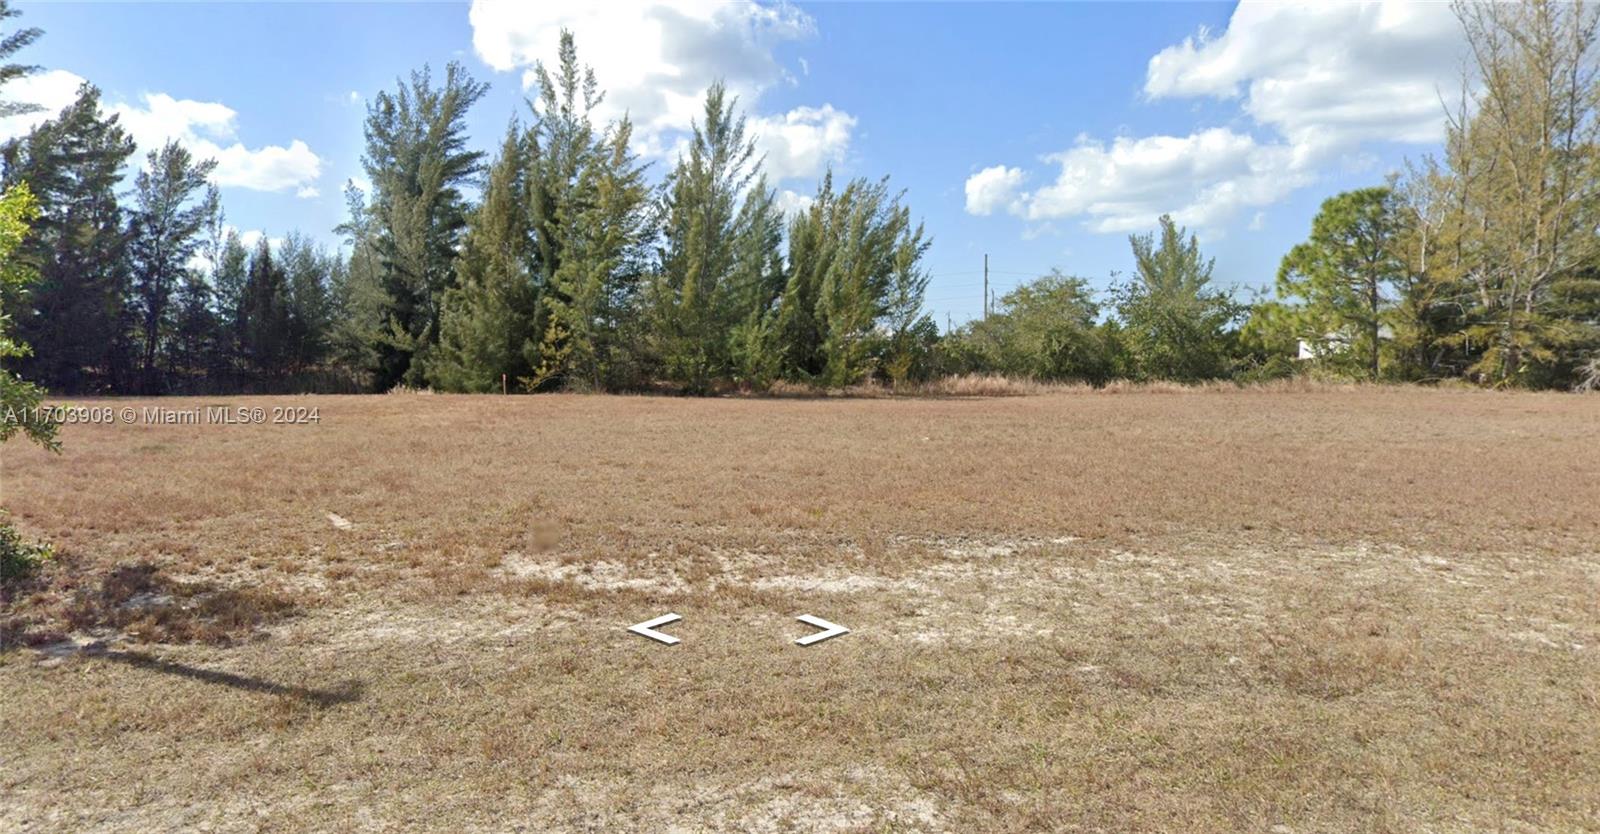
[1278,187,1406,379]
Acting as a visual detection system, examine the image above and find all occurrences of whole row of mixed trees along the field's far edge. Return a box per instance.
[0,3,1600,401]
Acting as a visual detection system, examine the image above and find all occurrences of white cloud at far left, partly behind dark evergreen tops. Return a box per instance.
[0,69,322,197]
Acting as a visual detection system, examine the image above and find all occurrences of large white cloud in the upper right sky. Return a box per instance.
[966,0,1464,232]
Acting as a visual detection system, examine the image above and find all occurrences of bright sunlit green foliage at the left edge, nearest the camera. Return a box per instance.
[0,184,59,450]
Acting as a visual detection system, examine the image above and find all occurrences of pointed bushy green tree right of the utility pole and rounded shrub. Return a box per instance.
[1112,215,1243,383]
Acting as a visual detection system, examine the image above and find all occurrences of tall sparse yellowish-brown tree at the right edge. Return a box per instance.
[1445,0,1600,386]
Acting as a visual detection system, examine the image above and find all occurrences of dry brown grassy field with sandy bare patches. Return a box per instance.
[0,389,1600,832]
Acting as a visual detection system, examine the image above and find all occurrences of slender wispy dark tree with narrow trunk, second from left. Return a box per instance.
[130,142,218,394]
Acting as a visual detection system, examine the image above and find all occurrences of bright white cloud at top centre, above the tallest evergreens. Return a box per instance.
[469,0,856,179]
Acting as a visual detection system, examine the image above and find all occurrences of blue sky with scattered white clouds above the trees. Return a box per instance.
[0,0,1459,325]
